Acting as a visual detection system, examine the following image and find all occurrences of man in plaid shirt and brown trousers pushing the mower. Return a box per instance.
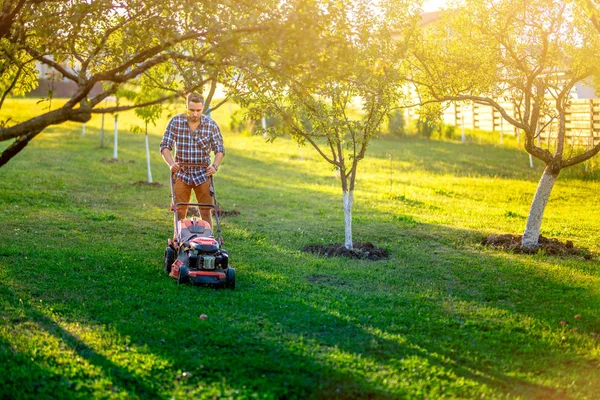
[160,93,225,226]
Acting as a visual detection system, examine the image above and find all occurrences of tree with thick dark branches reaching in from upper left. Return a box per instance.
[0,0,316,166]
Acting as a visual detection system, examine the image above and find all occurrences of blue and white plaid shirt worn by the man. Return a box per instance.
[160,114,225,186]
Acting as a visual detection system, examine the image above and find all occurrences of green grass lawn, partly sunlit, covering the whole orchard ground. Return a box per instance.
[0,100,600,399]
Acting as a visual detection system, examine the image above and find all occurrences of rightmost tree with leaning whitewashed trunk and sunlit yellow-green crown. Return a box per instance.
[413,0,600,248]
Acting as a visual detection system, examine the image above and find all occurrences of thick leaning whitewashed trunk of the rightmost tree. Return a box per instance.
[522,166,558,249]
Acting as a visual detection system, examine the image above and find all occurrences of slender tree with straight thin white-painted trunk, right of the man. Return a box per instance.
[232,1,417,249]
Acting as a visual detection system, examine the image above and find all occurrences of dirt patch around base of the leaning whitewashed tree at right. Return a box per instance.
[481,234,592,259]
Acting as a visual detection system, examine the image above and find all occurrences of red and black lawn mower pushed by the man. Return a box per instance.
[165,164,235,290]
